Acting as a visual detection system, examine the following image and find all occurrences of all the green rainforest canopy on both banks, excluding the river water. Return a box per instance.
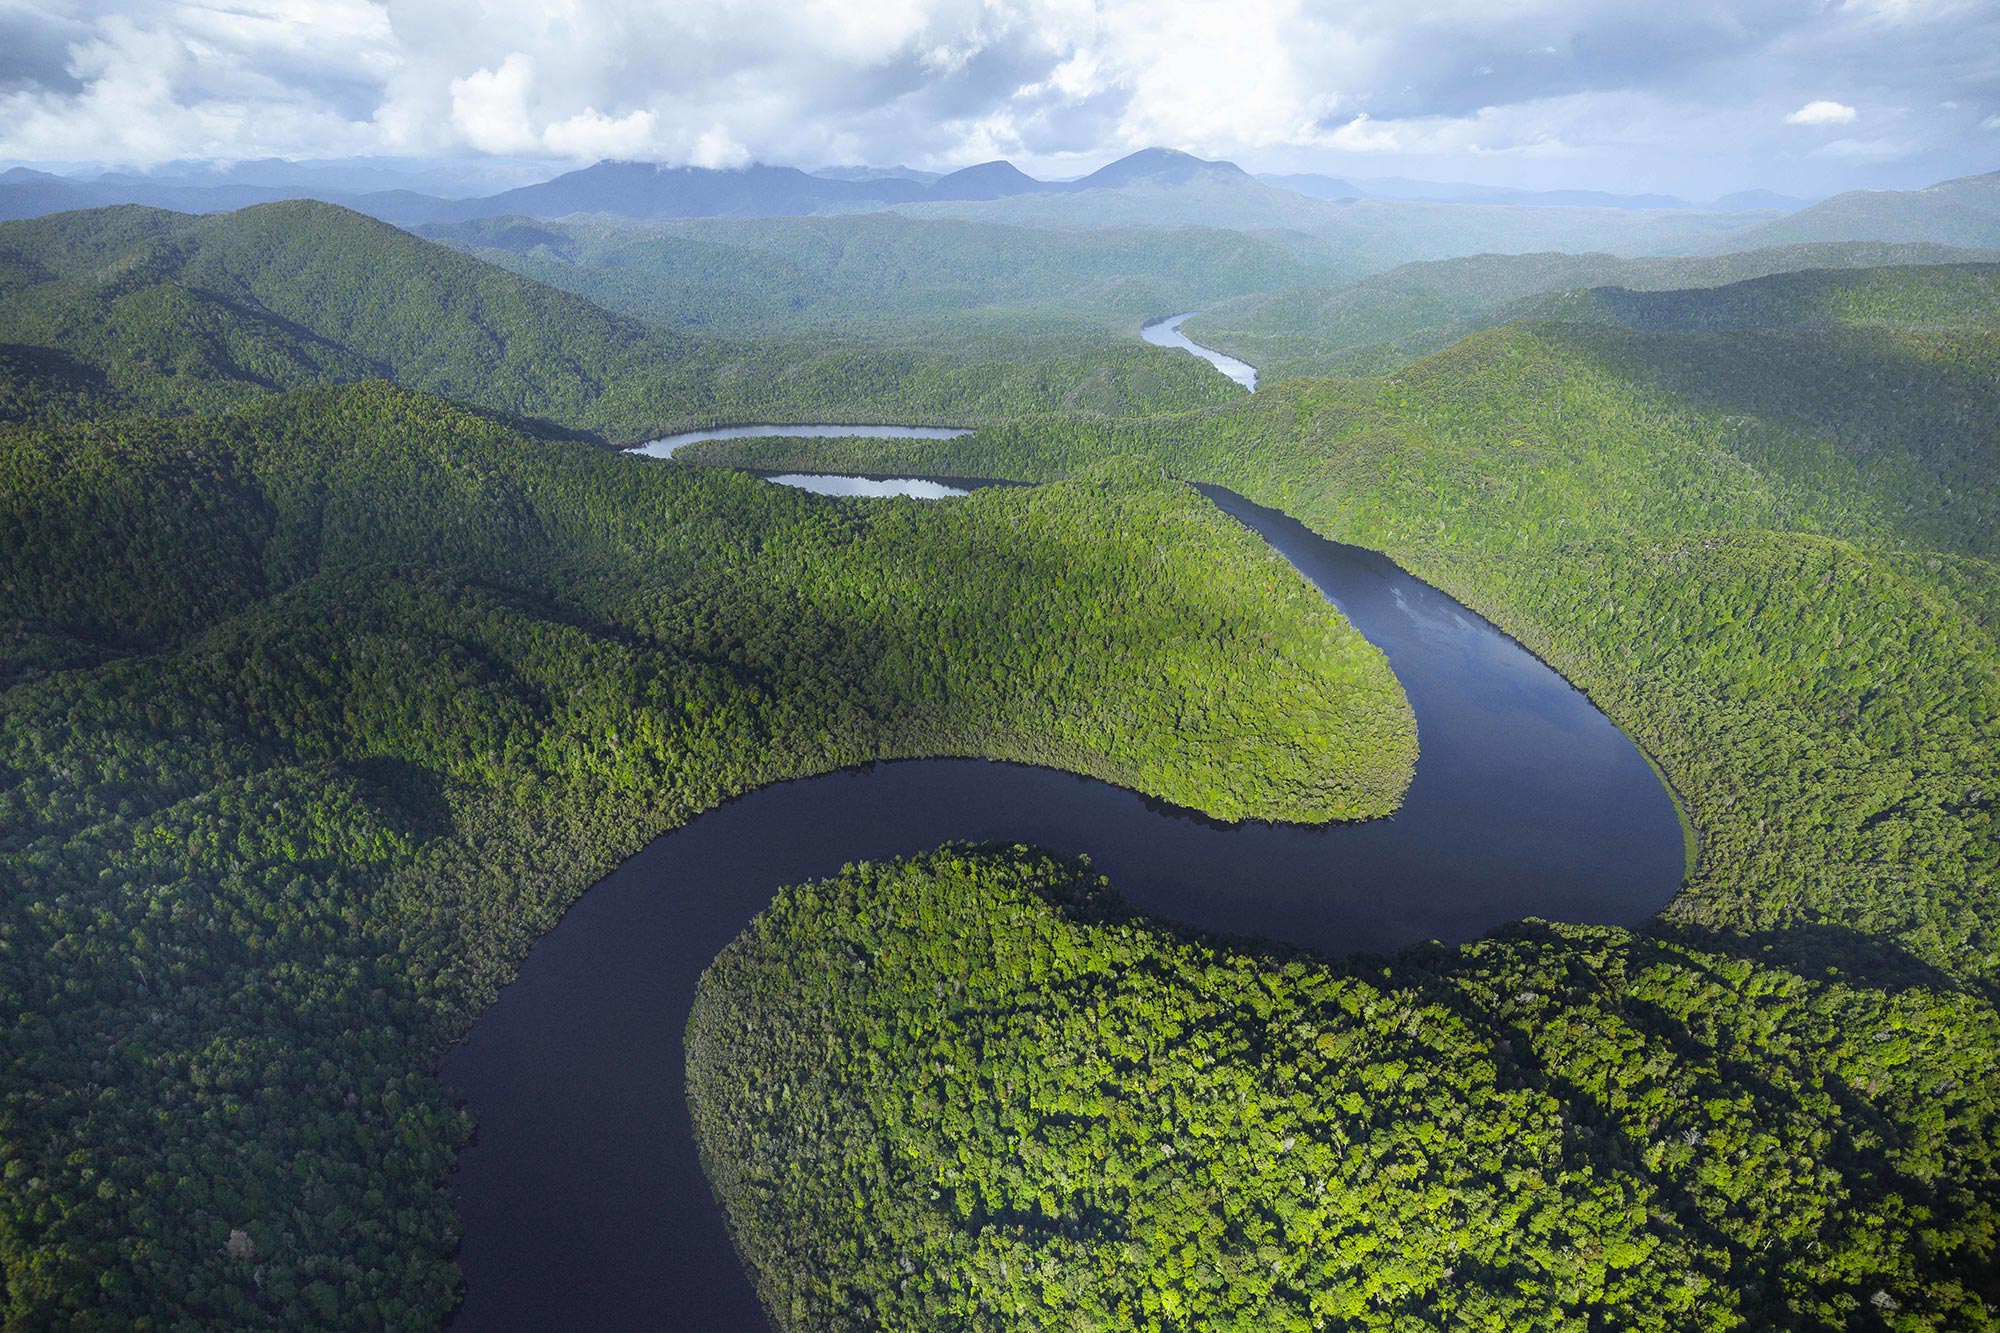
[0,204,2000,1331]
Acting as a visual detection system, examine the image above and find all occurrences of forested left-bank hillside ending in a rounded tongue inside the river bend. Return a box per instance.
[0,374,1416,1329]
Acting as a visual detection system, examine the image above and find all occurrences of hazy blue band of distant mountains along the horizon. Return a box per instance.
[0,148,2000,276]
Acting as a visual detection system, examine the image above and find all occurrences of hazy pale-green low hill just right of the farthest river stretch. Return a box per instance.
[1186,242,2000,384]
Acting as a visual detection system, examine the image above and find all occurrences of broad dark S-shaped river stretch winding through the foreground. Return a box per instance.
[444,490,1684,1333]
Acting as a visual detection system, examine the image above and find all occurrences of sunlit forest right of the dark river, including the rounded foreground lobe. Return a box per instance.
[690,270,2000,1331]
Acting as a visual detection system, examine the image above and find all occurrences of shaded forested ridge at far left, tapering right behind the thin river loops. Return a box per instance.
[0,200,1234,442]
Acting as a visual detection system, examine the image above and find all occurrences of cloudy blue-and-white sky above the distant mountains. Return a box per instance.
[0,0,2000,198]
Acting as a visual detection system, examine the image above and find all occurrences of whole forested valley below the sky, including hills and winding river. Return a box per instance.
[0,112,2000,1333]
